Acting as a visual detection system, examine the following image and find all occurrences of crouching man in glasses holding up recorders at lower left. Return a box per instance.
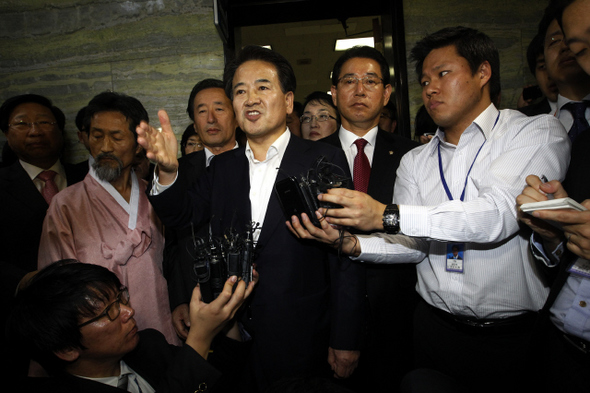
[8,260,255,393]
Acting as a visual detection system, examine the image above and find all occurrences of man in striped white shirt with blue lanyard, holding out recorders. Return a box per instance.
[289,27,570,392]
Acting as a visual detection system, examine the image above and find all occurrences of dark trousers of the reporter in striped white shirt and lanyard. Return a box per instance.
[414,301,536,392]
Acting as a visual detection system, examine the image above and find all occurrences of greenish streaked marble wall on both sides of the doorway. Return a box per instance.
[0,0,546,162]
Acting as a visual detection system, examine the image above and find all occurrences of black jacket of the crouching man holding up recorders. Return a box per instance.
[15,330,229,393]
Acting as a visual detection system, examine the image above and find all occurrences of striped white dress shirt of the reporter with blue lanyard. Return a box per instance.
[358,105,570,318]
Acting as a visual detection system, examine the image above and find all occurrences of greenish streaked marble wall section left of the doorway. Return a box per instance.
[0,0,224,162]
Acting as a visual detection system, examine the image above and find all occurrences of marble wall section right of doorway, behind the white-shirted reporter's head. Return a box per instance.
[404,0,548,132]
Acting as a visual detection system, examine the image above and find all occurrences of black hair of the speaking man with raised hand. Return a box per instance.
[223,45,297,99]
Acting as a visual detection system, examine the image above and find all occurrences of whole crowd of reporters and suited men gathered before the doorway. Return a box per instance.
[0,0,590,393]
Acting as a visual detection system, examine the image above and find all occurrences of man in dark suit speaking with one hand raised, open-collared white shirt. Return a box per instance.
[138,46,364,391]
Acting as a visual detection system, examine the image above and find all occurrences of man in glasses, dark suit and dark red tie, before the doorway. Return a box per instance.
[322,46,418,391]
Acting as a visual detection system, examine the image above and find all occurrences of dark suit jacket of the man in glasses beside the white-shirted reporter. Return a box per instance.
[320,130,419,391]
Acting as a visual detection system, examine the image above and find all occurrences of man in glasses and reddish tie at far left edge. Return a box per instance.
[0,94,84,373]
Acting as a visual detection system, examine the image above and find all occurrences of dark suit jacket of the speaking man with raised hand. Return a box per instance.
[150,136,364,390]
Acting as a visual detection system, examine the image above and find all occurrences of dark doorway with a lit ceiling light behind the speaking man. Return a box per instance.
[214,0,411,137]
